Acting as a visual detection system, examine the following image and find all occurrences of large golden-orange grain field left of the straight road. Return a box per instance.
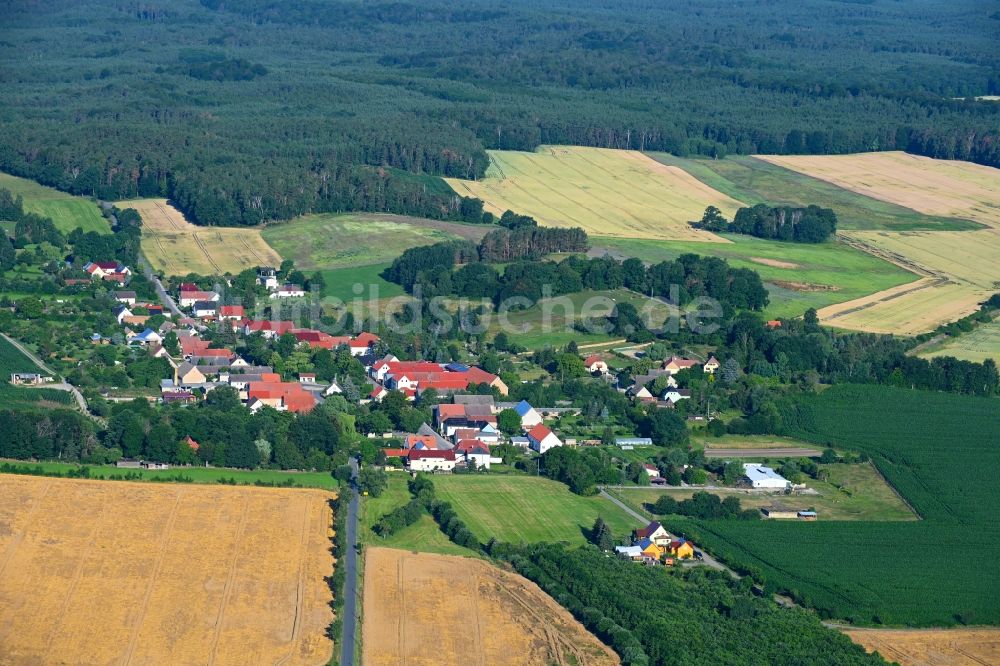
[0,475,333,665]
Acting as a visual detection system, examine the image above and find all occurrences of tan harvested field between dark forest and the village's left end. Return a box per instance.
[123,199,281,275]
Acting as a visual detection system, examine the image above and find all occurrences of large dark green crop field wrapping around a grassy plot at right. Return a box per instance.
[667,385,1000,626]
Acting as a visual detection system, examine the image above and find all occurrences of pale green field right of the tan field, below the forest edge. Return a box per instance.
[261,213,489,271]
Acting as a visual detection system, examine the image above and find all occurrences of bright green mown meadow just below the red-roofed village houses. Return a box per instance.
[434,475,641,544]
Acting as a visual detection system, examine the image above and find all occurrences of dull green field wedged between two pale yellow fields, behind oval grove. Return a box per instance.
[650,153,980,231]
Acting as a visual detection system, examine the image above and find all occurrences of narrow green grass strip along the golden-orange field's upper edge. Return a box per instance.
[5,460,337,490]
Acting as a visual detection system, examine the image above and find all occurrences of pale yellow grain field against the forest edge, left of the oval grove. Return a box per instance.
[446,146,743,243]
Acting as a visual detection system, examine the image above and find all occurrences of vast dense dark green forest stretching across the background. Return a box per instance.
[0,0,1000,225]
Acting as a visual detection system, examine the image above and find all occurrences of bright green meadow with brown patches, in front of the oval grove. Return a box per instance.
[591,234,917,317]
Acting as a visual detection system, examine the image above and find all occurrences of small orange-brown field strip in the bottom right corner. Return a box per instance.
[844,629,1000,666]
